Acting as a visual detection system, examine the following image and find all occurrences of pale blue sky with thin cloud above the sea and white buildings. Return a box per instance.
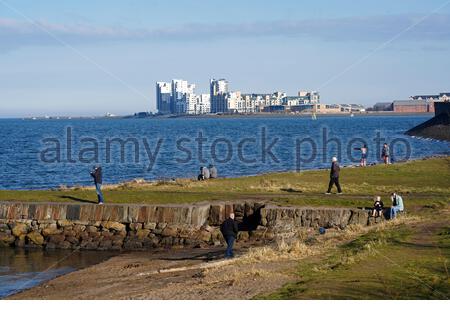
[0,0,450,117]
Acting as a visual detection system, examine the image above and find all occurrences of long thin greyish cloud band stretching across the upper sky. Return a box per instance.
[0,14,450,50]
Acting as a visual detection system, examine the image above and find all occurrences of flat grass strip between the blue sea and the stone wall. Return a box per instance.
[0,157,450,206]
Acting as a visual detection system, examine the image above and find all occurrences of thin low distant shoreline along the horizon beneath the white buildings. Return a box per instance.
[0,111,434,121]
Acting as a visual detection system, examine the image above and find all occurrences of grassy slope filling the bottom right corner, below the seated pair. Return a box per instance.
[256,210,450,299]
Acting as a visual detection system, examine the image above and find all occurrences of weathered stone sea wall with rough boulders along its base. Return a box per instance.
[0,202,370,250]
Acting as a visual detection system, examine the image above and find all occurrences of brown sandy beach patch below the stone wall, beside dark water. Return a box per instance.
[8,247,293,300]
